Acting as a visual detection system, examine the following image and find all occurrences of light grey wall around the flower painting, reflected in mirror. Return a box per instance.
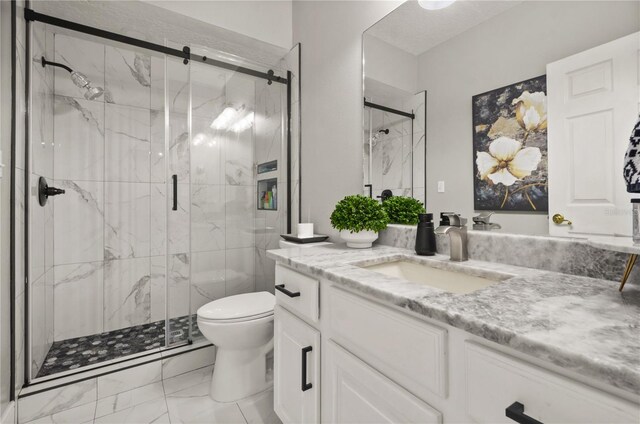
[419,1,640,234]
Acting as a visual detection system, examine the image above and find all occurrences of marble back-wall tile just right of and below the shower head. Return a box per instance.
[104,104,151,182]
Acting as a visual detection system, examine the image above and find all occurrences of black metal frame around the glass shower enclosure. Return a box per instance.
[21,5,301,389]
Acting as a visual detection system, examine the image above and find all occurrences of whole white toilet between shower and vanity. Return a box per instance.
[198,292,276,402]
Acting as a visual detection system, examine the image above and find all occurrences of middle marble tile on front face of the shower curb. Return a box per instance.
[98,361,162,399]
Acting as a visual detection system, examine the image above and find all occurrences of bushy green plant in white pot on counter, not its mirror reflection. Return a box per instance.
[331,195,389,249]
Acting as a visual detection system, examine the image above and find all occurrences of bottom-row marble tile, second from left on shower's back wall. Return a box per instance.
[104,258,152,332]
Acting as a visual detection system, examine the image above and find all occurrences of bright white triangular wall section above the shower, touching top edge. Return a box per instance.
[143,0,293,49]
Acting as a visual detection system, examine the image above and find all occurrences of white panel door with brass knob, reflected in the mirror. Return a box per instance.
[547,33,640,237]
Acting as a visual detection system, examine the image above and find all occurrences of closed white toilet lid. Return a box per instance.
[198,292,276,320]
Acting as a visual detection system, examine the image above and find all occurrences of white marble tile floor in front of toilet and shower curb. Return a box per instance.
[21,366,281,424]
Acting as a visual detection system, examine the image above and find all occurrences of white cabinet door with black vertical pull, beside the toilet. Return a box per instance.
[273,306,320,424]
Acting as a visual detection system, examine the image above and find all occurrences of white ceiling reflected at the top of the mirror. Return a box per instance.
[365,0,522,55]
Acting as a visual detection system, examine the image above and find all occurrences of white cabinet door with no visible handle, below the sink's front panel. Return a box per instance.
[323,341,442,424]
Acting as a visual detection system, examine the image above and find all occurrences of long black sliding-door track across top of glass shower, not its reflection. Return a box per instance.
[24,8,288,84]
